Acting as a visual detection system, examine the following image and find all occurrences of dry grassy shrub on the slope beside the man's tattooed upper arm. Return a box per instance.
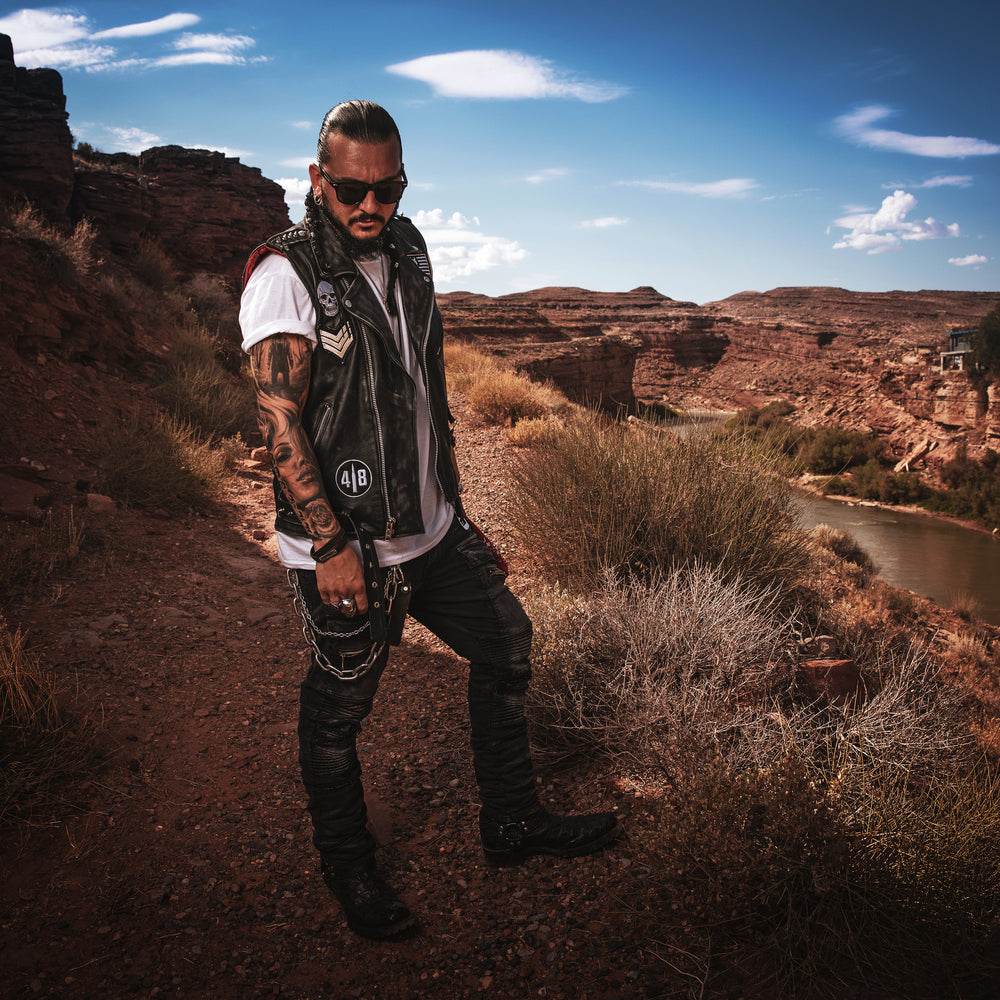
[153,314,256,442]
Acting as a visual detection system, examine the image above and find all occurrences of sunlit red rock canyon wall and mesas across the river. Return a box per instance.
[439,288,1000,466]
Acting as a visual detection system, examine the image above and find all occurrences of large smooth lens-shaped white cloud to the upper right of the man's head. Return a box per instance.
[386,49,628,103]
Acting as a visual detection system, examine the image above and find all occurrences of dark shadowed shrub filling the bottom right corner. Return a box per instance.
[639,755,1000,1000]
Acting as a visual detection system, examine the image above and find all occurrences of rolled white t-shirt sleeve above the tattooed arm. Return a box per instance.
[240,253,316,351]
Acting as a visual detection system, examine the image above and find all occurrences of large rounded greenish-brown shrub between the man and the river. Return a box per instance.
[512,420,807,588]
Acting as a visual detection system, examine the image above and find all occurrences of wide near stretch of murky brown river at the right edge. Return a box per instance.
[801,496,1000,625]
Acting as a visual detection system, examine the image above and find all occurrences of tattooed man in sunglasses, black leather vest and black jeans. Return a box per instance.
[240,101,619,938]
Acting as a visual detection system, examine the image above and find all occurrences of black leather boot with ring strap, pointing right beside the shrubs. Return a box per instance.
[479,805,621,868]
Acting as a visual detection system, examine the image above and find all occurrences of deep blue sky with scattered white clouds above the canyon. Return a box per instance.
[0,0,1000,303]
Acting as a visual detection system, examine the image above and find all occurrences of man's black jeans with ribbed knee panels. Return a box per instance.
[293,518,538,867]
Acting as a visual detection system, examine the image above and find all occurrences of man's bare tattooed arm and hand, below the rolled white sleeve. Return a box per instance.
[250,333,368,613]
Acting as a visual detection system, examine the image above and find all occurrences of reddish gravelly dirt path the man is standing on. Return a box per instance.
[0,361,668,1000]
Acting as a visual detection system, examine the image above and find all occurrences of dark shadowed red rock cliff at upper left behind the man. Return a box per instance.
[0,35,290,281]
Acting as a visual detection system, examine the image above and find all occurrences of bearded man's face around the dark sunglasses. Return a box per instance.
[309,133,403,252]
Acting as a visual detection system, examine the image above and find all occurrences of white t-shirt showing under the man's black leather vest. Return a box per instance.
[240,253,454,569]
